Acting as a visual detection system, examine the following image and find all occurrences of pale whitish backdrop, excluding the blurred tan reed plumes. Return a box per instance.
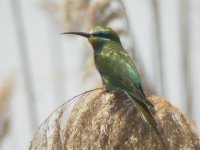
[0,0,200,150]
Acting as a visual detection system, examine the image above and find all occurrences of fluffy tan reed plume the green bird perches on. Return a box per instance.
[29,90,200,150]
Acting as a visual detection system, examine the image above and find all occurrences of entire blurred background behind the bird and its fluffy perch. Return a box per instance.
[0,0,200,150]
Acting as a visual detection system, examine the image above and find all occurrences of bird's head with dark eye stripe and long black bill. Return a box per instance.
[63,26,121,50]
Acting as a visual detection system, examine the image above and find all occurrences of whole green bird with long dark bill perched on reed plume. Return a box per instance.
[63,27,165,147]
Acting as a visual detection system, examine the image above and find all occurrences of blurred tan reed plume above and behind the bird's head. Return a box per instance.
[43,0,129,34]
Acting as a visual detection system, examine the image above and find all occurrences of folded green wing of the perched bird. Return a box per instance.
[97,51,152,106]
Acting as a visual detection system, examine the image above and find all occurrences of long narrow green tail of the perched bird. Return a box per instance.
[133,98,168,150]
